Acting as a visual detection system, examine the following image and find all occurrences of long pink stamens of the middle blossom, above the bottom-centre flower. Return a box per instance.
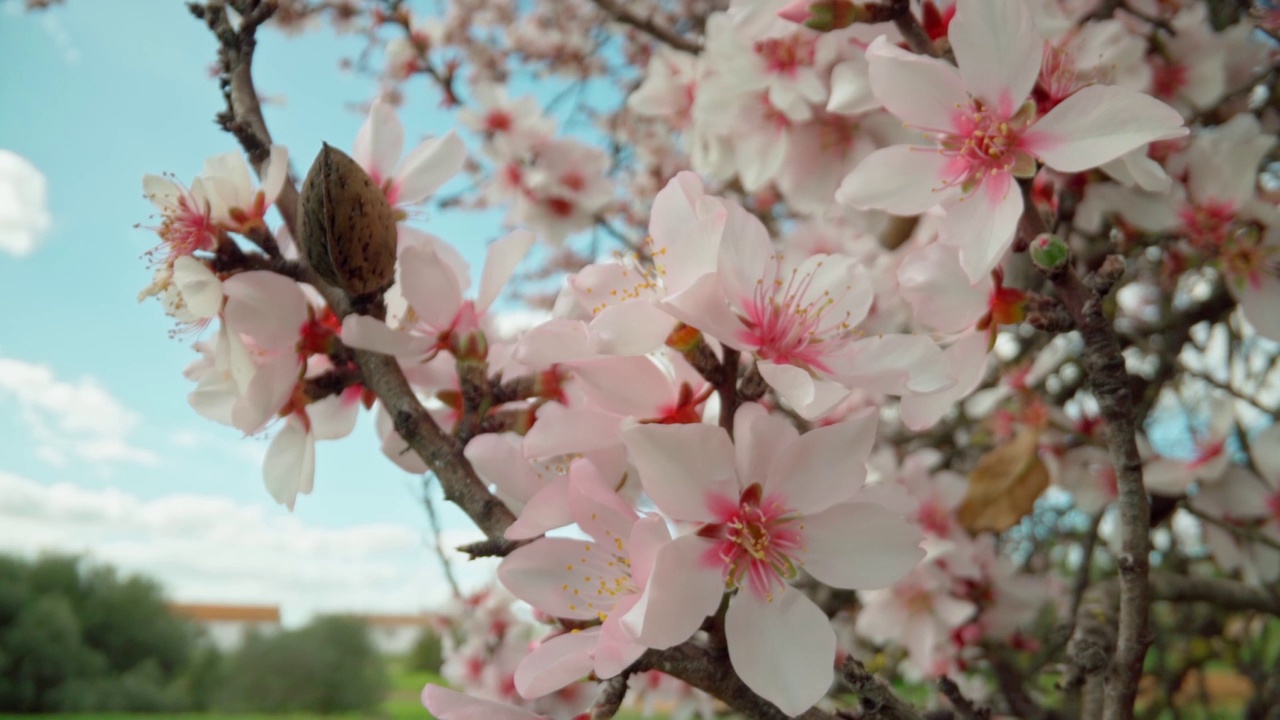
[742,258,852,373]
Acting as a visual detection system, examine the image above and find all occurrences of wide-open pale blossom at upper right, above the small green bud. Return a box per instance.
[836,0,1188,281]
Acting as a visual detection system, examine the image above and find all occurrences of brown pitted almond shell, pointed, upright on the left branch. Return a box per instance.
[298,143,396,297]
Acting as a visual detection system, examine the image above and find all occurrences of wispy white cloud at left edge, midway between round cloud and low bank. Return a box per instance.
[0,356,160,466]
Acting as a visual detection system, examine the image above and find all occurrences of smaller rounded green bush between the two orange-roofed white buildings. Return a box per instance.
[216,616,389,714]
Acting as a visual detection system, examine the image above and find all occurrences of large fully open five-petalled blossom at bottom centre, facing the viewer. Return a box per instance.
[622,404,924,716]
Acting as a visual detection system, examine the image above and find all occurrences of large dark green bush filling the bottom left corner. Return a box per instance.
[0,556,196,712]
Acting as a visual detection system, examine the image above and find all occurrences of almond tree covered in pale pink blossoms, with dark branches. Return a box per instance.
[49,0,1280,720]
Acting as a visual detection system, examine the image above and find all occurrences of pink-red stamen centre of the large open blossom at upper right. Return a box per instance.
[938,97,1036,192]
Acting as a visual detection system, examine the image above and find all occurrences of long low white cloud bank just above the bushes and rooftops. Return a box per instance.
[0,473,494,624]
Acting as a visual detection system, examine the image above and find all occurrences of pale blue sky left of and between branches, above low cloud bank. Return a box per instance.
[0,0,535,617]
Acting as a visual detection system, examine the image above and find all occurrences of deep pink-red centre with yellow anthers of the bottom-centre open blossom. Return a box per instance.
[698,484,804,601]
